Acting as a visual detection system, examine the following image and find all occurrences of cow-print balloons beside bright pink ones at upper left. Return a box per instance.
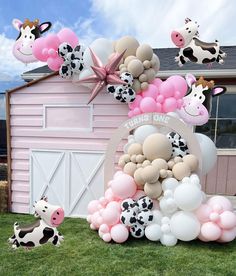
[58,42,84,79]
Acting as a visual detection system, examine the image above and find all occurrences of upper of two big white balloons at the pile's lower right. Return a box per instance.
[174,183,202,211]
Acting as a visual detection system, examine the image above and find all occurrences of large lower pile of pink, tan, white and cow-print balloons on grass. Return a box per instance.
[88,125,236,246]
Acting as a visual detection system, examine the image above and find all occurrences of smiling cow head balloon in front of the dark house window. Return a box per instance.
[177,74,226,126]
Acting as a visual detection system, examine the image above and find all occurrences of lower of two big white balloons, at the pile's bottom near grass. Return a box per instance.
[170,211,200,241]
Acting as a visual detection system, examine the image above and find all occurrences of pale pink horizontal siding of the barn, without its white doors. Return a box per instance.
[9,76,128,213]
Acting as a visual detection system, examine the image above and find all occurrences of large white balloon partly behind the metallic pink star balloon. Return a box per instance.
[83,38,114,68]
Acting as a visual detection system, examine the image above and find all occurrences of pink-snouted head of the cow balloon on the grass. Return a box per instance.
[34,197,64,227]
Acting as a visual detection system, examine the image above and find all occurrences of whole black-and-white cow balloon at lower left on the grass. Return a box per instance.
[9,197,64,249]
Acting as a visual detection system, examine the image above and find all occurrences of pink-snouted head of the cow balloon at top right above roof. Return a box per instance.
[171,18,199,48]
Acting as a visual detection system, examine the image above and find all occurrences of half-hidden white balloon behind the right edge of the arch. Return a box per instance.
[195,133,217,175]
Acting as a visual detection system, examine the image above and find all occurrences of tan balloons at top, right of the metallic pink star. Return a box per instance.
[114,36,160,93]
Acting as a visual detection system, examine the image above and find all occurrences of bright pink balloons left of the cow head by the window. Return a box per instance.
[128,75,188,117]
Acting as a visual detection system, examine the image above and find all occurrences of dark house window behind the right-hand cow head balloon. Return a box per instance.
[196,93,236,149]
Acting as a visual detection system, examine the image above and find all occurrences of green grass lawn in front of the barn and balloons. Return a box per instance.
[0,214,236,276]
